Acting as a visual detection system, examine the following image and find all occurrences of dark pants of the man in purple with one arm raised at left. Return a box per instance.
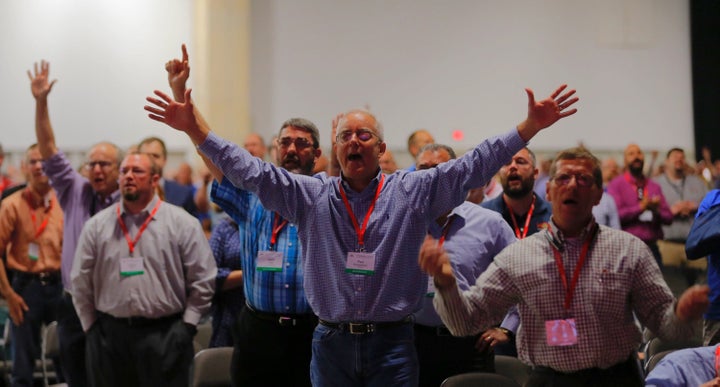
[57,292,88,387]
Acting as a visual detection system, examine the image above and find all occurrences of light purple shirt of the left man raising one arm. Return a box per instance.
[43,151,120,291]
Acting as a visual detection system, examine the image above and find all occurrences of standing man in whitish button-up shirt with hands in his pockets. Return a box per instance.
[72,153,217,387]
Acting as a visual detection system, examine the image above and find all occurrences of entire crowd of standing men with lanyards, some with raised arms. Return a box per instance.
[0,46,720,386]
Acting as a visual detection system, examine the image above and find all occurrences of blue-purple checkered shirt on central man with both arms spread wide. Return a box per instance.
[198,129,526,322]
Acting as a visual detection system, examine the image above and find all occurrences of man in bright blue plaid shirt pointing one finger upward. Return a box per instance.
[166,45,322,386]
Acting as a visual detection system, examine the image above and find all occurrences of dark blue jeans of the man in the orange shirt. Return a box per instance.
[11,273,62,386]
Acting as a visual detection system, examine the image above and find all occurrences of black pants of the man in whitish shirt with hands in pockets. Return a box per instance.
[87,314,195,387]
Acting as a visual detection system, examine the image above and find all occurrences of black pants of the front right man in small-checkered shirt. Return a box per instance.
[525,356,645,387]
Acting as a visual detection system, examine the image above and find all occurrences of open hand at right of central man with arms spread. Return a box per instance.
[517,85,578,142]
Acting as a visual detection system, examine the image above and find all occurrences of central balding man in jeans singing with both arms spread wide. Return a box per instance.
[145,50,577,386]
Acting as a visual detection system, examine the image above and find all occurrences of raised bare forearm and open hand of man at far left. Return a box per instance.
[28,60,58,160]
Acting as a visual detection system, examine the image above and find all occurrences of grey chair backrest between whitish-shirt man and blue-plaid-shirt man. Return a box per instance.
[190,347,233,387]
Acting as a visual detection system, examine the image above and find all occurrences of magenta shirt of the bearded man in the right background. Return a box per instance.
[608,173,673,242]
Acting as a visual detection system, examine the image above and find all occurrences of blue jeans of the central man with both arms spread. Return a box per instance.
[310,323,418,387]
